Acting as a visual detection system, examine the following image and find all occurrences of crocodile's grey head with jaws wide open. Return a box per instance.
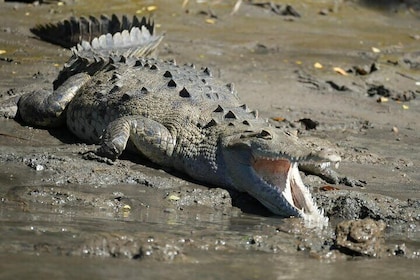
[223,128,334,225]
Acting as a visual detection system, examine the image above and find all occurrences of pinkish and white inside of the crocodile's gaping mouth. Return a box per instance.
[253,158,315,216]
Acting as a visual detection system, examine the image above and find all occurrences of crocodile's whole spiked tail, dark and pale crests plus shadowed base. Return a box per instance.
[31,15,163,88]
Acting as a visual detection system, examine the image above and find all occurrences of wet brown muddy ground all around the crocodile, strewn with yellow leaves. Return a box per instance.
[0,1,420,279]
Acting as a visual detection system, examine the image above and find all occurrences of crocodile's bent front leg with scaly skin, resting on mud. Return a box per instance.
[92,116,176,165]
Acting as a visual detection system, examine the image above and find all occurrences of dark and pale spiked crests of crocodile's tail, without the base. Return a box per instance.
[31,15,163,58]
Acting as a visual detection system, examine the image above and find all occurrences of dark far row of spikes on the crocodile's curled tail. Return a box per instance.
[31,15,154,48]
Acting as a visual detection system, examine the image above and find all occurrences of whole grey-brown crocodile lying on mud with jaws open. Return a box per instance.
[12,14,358,225]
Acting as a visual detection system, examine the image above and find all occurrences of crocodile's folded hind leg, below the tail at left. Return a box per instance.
[18,73,90,127]
